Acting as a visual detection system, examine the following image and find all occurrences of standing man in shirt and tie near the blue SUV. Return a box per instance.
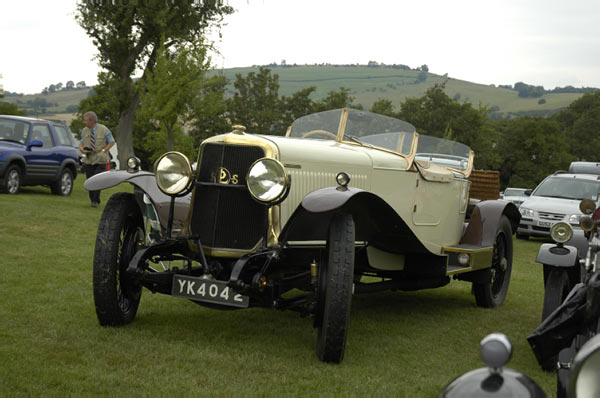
[79,112,115,207]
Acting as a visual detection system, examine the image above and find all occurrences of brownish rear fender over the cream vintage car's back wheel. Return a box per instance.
[460,200,521,247]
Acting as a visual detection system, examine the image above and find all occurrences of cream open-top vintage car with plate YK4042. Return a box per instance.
[86,108,520,362]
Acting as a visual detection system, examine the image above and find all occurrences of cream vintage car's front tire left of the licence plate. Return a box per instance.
[93,192,144,326]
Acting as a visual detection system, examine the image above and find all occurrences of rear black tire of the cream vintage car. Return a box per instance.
[473,215,513,308]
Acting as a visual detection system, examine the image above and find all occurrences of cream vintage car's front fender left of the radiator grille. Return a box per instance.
[83,170,191,233]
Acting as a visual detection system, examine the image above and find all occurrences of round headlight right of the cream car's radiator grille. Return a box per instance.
[246,158,290,205]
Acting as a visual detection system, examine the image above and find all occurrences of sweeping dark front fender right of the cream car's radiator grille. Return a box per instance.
[279,187,429,253]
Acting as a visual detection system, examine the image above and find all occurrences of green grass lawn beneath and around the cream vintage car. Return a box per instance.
[0,179,555,397]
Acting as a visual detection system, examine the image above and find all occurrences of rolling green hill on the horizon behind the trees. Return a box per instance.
[3,65,582,116]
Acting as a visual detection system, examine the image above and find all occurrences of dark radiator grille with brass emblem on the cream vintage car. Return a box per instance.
[191,143,268,250]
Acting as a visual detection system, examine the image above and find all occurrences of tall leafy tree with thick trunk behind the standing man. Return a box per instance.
[76,0,233,168]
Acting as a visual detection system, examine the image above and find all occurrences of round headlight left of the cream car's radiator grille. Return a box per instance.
[154,152,192,195]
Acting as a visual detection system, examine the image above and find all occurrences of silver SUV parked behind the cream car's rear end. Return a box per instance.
[517,162,600,239]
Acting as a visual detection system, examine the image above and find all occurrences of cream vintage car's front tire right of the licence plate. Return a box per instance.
[317,214,355,363]
